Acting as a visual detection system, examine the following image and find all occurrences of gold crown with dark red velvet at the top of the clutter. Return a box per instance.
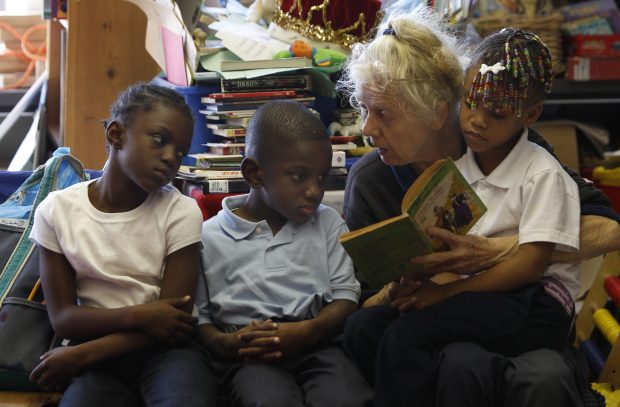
[272,0,383,48]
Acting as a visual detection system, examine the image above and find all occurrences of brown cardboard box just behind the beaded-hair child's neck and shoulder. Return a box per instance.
[532,122,579,172]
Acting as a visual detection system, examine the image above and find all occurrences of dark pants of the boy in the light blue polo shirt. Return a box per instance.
[214,345,373,407]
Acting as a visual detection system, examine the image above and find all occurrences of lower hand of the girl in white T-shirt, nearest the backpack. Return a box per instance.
[30,346,84,391]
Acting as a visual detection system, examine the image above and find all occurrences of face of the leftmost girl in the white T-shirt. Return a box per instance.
[116,104,193,192]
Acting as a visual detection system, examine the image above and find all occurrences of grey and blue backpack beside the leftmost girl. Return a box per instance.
[0,148,88,391]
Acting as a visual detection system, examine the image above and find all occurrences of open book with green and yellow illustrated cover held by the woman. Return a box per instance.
[340,159,486,288]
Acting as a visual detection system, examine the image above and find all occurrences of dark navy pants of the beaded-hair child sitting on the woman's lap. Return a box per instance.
[344,285,571,407]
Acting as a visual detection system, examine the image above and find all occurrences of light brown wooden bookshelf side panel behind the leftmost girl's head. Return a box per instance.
[48,0,159,169]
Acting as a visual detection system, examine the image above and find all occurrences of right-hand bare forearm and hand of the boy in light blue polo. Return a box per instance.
[239,300,357,358]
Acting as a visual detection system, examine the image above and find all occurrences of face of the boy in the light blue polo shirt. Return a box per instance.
[259,140,332,224]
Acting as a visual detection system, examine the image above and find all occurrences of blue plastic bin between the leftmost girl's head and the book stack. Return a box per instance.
[152,77,220,165]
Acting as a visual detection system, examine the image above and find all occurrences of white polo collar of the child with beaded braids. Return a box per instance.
[463,128,532,188]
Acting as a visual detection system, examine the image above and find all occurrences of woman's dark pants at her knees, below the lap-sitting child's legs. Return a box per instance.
[435,342,585,407]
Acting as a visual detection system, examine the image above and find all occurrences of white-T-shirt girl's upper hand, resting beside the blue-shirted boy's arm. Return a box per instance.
[137,296,198,345]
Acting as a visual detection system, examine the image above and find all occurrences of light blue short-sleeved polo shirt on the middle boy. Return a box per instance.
[196,195,360,327]
